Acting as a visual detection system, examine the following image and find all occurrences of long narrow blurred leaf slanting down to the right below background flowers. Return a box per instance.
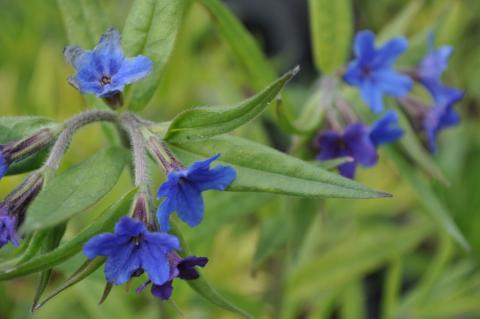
[387,150,470,251]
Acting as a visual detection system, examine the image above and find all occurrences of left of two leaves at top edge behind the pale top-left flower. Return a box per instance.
[57,0,109,48]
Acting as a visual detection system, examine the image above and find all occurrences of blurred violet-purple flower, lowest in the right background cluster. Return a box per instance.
[316,123,378,178]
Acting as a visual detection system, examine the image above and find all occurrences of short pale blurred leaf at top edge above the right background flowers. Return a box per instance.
[377,0,424,43]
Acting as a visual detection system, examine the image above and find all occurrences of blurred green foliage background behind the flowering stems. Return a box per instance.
[0,0,480,319]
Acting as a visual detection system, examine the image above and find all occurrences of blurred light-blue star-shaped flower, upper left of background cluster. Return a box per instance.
[343,31,413,112]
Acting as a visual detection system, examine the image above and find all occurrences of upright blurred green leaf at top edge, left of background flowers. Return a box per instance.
[309,0,353,74]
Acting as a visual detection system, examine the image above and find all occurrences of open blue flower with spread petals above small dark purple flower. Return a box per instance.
[83,217,181,285]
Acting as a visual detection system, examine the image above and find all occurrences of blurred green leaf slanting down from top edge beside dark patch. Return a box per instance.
[197,0,276,90]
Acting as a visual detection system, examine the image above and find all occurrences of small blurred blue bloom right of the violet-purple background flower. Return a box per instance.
[370,110,403,147]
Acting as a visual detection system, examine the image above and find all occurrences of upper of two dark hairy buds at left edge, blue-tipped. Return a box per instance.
[0,128,55,178]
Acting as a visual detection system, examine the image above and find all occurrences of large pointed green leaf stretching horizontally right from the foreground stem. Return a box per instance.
[170,135,389,198]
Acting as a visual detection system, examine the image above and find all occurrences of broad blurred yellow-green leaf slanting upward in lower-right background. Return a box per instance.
[289,222,432,296]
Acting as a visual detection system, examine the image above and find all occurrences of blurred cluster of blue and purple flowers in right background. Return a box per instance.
[315,31,463,178]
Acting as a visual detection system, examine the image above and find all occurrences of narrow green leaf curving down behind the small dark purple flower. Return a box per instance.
[172,222,253,318]
